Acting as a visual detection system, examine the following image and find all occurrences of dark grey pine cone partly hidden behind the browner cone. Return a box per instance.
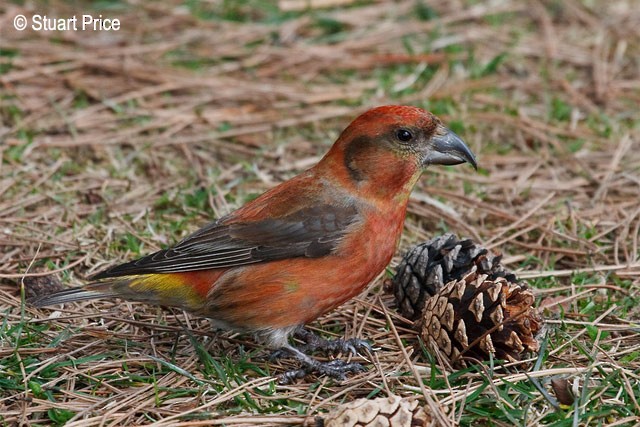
[392,233,516,320]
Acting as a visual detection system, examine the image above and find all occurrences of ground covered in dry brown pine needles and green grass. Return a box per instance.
[0,0,640,426]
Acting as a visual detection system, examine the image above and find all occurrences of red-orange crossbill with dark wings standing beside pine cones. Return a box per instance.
[30,105,477,380]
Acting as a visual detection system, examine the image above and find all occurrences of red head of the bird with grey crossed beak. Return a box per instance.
[321,105,477,201]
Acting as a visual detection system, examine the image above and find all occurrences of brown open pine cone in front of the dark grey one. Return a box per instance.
[416,266,542,366]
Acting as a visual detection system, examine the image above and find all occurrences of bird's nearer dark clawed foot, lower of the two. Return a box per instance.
[279,345,365,384]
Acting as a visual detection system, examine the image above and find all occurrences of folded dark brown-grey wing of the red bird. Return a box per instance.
[93,205,358,279]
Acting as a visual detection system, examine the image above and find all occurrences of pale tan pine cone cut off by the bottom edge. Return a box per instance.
[316,396,431,427]
